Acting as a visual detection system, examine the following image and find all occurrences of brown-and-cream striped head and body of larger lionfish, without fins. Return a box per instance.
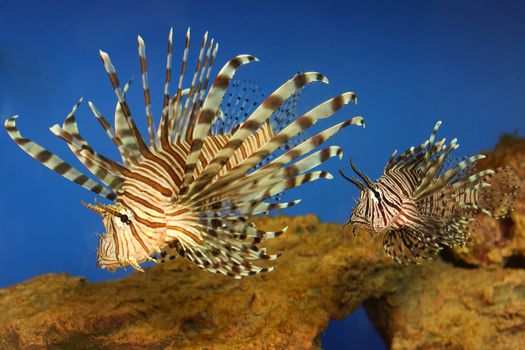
[98,124,278,268]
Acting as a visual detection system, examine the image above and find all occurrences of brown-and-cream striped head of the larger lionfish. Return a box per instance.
[82,202,159,272]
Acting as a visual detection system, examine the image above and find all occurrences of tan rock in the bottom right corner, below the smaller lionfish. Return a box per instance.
[365,261,525,349]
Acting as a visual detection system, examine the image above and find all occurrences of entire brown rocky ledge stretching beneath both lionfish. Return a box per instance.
[0,137,525,349]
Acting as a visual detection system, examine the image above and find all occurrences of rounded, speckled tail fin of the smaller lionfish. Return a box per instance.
[478,167,521,218]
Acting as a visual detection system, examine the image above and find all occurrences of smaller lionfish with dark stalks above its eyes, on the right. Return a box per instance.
[340,122,519,264]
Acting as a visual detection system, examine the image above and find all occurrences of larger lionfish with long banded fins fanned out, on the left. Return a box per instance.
[5,29,364,278]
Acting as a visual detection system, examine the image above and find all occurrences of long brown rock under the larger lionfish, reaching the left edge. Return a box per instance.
[0,216,407,349]
